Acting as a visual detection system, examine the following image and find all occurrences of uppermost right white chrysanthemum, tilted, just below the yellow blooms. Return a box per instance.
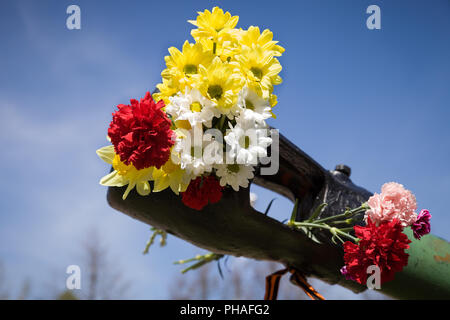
[237,86,272,123]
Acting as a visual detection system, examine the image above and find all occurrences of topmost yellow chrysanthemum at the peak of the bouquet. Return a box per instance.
[188,7,239,41]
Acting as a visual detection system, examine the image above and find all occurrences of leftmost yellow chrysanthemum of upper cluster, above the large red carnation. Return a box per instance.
[161,41,214,89]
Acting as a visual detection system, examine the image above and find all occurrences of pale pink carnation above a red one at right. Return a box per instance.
[364,182,417,227]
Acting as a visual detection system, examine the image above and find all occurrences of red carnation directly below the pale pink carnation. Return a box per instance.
[344,218,411,285]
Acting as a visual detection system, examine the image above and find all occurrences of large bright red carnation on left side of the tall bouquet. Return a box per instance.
[108,92,174,169]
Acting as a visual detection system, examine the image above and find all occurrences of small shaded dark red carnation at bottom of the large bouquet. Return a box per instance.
[181,176,222,210]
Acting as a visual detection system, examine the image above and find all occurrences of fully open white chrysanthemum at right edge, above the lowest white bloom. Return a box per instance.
[224,110,272,165]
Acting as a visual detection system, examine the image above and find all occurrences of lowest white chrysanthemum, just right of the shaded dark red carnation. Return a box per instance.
[215,163,255,191]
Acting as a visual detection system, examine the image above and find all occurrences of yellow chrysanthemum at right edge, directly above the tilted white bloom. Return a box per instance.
[236,45,282,99]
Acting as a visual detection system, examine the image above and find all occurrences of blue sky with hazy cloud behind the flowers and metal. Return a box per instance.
[0,0,450,298]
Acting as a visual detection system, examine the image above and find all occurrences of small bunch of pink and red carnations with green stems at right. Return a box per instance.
[288,182,431,285]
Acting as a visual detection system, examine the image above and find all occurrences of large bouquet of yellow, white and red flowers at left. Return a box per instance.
[97,7,284,210]
